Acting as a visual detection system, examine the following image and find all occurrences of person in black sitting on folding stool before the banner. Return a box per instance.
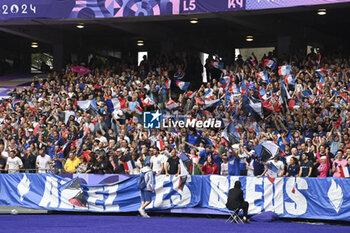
[226,180,249,223]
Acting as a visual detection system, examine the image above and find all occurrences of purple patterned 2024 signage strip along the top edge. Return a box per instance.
[0,0,350,20]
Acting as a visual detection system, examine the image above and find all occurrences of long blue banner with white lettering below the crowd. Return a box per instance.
[0,174,350,220]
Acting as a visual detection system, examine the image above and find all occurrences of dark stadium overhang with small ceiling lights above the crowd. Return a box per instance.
[0,0,350,71]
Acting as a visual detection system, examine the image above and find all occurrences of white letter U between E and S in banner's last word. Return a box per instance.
[264,178,284,214]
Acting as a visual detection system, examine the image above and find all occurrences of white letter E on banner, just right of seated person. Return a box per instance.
[245,176,263,214]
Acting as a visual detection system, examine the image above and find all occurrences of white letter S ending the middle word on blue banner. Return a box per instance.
[171,176,191,206]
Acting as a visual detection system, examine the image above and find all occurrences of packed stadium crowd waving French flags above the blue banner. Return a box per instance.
[0,50,350,177]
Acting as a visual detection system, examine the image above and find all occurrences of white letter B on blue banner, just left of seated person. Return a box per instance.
[208,175,228,209]
